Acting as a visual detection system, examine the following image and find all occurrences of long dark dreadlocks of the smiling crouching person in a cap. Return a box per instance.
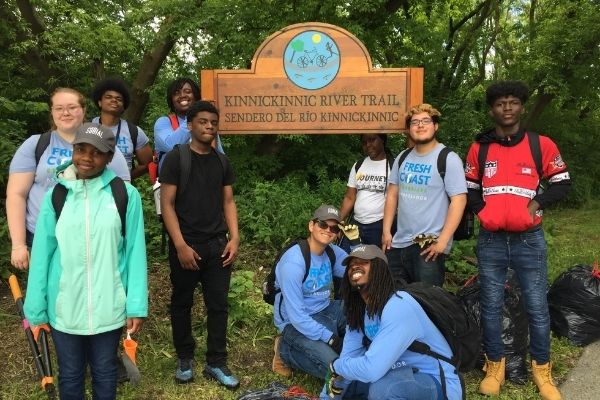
[340,258,396,332]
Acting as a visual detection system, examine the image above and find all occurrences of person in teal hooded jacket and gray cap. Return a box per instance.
[25,123,148,399]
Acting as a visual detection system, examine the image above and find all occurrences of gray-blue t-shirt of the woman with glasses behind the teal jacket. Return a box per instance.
[8,131,131,233]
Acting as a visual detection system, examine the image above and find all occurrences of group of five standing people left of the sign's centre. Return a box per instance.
[6,78,239,399]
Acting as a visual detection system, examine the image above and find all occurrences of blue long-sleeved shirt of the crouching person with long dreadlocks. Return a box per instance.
[333,291,462,400]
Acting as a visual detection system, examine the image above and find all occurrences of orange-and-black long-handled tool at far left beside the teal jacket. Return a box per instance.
[8,275,56,399]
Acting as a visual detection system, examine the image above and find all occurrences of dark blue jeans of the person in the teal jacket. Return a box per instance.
[51,328,122,400]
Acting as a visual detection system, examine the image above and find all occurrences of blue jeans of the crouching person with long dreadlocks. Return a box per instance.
[321,366,444,400]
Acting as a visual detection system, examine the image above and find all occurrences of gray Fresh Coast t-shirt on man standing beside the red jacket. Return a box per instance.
[389,143,467,253]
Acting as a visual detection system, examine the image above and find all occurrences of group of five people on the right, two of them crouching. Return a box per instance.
[272,81,571,400]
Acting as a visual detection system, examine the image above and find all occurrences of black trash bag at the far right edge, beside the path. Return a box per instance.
[548,265,600,346]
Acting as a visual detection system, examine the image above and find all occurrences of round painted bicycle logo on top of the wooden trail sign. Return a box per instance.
[283,30,340,90]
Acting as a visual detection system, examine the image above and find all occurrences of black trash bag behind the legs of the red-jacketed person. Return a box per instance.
[458,270,529,385]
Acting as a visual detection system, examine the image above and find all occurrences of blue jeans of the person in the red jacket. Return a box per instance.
[477,228,550,364]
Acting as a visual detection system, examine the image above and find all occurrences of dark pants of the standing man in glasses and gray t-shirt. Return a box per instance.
[386,244,446,287]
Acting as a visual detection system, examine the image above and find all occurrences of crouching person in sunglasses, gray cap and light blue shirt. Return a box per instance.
[273,205,354,379]
